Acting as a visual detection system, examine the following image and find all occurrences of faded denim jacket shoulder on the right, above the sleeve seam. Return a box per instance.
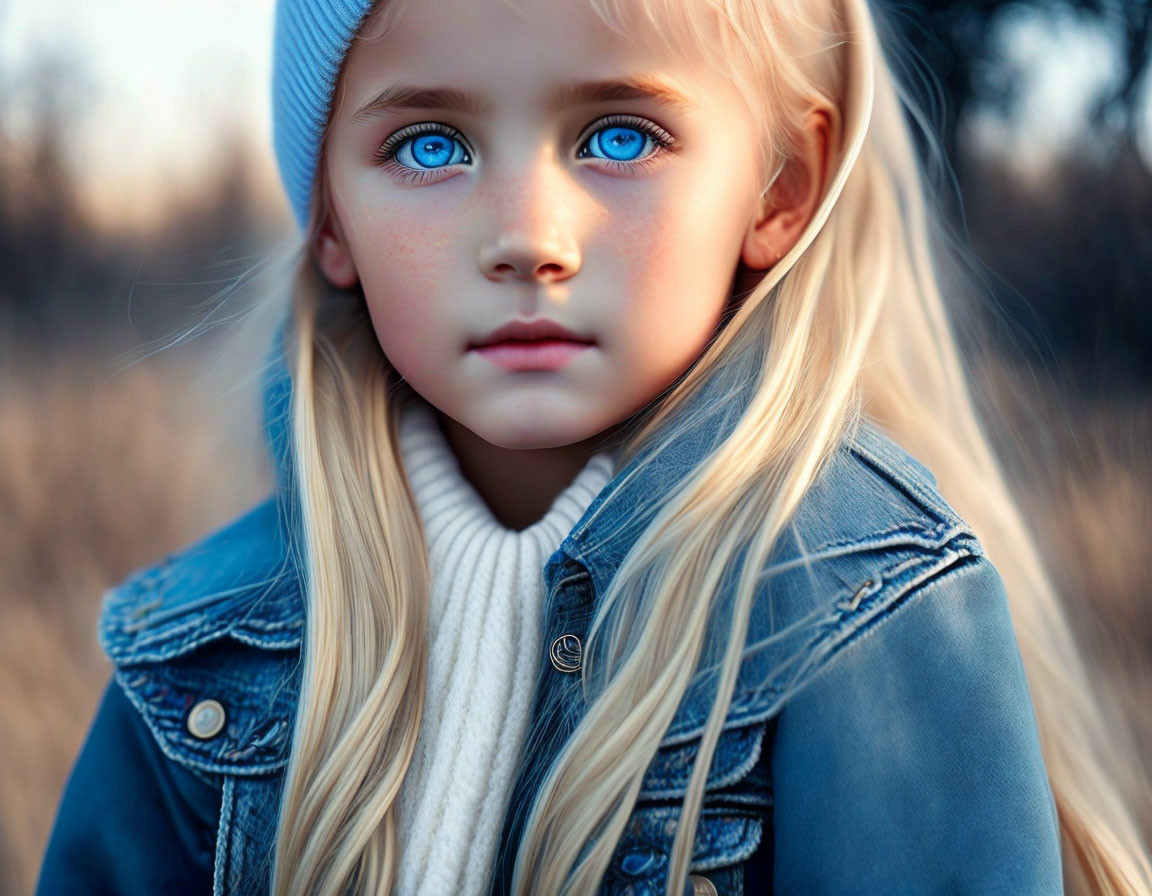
[673,420,1008,737]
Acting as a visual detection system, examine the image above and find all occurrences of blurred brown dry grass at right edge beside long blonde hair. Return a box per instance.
[980,359,1152,843]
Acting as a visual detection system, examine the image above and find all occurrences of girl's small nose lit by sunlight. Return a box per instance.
[479,153,581,283]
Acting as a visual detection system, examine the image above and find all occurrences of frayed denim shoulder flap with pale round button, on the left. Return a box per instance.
[99,498,304,773]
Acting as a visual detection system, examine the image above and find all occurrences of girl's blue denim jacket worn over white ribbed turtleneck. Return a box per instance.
[37,329,1062,896]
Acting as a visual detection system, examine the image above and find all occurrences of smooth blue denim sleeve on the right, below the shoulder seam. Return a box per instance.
[772,541,1062,894]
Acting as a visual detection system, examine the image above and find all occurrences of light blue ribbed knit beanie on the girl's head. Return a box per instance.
[272,0,373,229]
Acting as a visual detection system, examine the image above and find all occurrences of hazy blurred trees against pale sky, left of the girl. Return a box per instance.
[0,51,281,354]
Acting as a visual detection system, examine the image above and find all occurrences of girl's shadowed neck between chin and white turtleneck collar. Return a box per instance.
[437,411,619,531]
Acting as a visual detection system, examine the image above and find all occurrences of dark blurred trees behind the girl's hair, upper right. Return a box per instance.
[879,0,1152,384]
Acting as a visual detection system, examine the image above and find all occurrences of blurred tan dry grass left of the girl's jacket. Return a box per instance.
[0,345,271,894]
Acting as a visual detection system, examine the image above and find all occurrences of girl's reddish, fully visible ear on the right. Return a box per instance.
[740,107,835,271]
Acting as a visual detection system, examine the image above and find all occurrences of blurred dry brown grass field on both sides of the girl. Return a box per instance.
[0,347,1152,893]
